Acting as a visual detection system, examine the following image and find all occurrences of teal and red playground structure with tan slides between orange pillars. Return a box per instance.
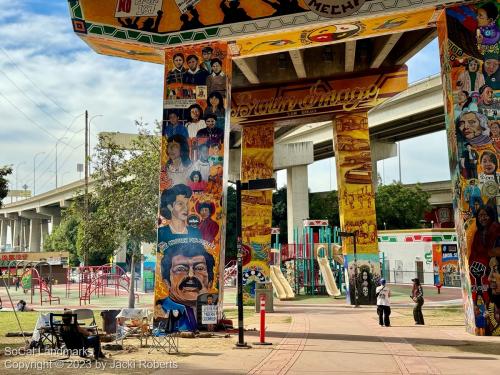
[280,220,344,297]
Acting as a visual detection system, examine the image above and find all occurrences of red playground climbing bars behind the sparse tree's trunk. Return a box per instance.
[66,264,139,305]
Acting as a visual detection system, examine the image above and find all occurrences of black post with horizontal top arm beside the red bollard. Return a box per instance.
[236,178,276,349]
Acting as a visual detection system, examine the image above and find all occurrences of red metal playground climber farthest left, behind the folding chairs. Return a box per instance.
[7,260,61,305]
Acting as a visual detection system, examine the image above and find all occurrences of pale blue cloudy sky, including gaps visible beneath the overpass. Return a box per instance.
[0,0,449,201]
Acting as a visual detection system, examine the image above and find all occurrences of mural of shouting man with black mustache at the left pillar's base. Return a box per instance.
[158,241,215,331]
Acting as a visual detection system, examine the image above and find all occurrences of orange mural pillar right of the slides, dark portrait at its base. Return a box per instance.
[333,113,380,305]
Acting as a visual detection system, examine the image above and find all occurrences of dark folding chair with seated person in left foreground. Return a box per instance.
[49,313,91,362]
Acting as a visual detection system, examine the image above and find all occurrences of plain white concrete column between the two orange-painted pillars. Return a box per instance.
[286,165,309,244]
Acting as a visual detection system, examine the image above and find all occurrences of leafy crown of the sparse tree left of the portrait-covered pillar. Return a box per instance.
[77,122,160,261]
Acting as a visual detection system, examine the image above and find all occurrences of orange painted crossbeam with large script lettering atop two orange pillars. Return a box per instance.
[231,67,408,124]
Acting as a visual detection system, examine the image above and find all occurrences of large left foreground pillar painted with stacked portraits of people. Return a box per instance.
[155,41,231,331]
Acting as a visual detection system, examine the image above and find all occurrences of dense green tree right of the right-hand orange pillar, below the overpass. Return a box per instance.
[376,182,431,229]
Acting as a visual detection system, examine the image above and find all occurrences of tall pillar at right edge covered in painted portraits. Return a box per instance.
[434,6,500,336]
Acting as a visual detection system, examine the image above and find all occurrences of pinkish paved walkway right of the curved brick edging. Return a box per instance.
[249,303,500,374]
